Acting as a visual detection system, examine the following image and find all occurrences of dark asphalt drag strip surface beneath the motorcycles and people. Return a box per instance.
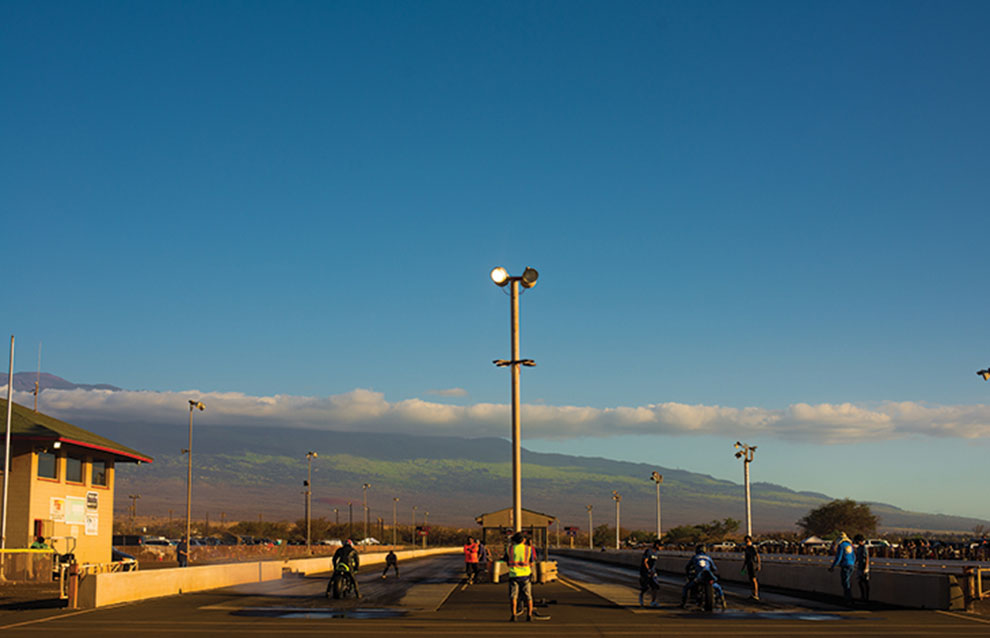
[0,556,990,638]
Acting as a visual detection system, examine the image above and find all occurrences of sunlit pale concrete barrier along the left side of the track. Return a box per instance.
[77,547,462,609]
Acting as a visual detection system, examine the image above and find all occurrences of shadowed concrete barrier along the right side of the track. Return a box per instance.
[552,549,965,610]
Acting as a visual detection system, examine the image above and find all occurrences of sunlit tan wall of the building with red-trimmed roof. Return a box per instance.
[18,445,114,563]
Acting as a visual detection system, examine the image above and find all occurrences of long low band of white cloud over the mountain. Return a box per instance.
[5,389,990,443]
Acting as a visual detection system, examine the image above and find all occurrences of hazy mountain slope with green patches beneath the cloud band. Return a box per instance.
[99,424,987,531]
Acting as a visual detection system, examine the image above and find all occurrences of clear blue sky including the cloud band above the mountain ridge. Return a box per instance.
[0,2,990,519]
